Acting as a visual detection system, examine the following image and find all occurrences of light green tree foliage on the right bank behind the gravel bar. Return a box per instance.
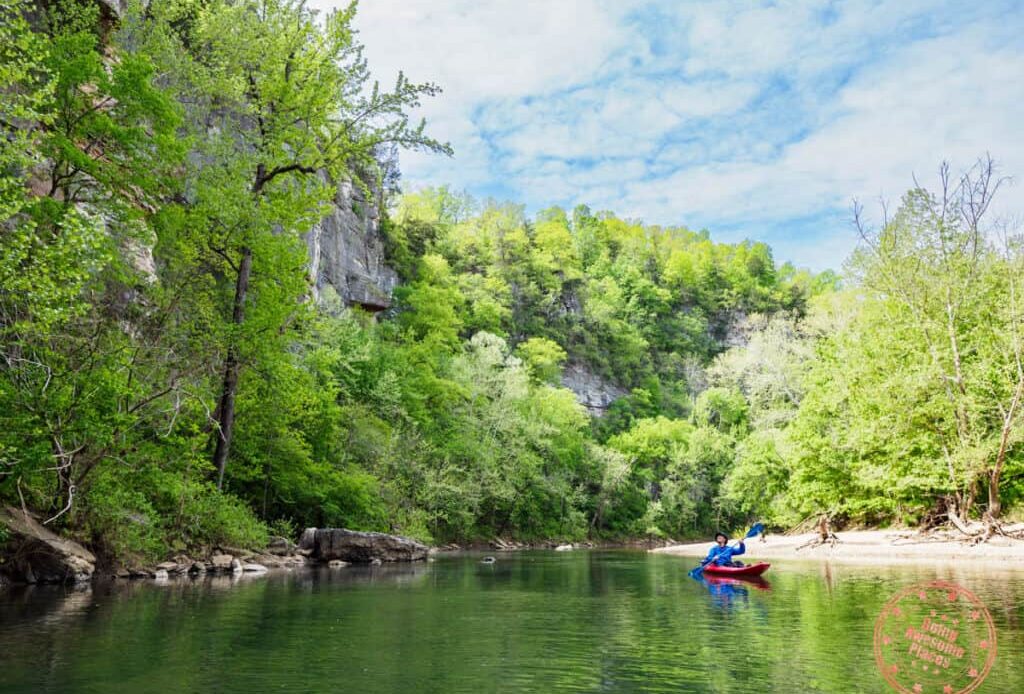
[701,160,1024,524]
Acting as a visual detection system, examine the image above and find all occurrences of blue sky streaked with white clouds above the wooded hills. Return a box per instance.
[309,0,1024,270]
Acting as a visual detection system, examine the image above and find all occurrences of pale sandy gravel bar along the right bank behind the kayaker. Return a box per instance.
[651,530,1024,570]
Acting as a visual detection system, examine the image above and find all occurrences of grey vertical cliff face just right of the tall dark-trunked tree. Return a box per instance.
[306,181,398,312]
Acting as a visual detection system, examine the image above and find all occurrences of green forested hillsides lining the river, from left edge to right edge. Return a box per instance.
[0,0,1024,569]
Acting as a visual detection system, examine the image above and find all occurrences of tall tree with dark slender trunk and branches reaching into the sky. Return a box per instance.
[146,0,451,486]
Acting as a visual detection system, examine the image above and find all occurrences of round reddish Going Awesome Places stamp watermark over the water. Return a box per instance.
[874,580,995,694]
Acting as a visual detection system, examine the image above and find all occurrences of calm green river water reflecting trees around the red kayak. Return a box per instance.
[0,551,1024,694]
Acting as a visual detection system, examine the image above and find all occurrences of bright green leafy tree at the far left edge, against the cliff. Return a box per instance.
[0,0,185,520]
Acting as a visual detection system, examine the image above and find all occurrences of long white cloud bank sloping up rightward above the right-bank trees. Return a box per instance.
[624,25,1024,223]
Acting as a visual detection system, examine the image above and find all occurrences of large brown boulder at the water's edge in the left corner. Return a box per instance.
[0,507,96,583]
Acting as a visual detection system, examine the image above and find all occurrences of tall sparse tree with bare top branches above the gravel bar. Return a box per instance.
[852,158,1024,526]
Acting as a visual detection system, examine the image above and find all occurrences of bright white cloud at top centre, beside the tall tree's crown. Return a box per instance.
[310,0,632,105]
